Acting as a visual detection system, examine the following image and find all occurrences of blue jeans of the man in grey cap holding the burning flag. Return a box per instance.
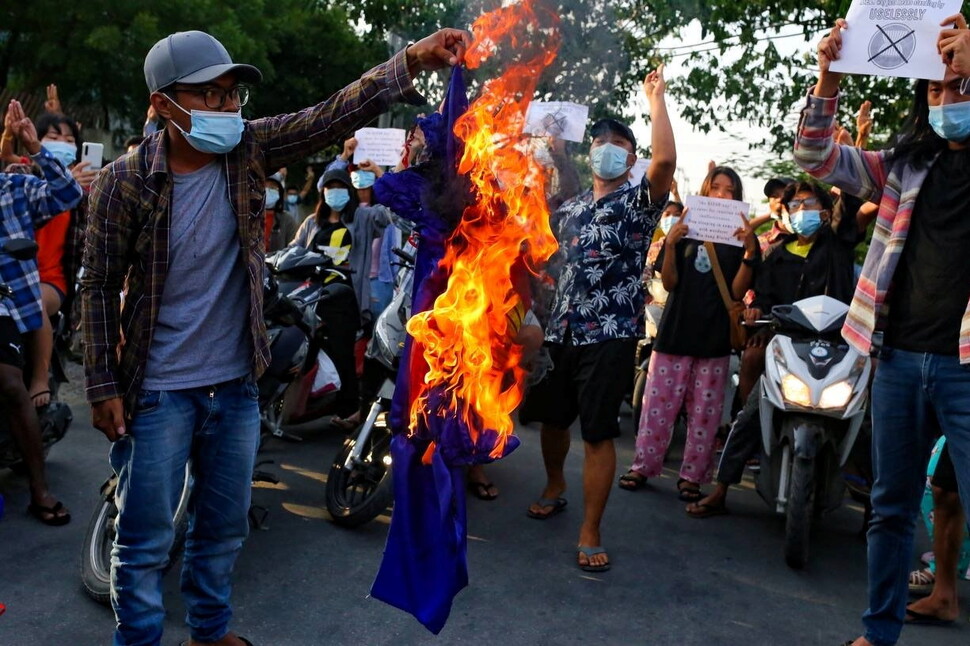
[110,378,259,646]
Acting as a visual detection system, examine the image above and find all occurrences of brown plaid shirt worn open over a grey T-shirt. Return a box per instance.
[81,51,424,413]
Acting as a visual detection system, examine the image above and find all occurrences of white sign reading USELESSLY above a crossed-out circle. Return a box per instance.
[829,0,963,81]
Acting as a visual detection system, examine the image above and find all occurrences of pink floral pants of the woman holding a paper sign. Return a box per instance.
[630,352,731,484]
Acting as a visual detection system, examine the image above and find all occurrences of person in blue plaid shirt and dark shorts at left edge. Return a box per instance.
[0,101,83,525]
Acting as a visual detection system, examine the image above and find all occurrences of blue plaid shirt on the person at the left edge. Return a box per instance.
[0,148,83,333]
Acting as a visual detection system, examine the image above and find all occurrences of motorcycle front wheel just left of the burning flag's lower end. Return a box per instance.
[327,424,394,527]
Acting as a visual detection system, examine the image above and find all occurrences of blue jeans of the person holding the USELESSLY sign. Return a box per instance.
[862,348,970,646]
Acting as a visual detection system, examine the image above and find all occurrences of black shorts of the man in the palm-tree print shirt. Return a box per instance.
[519,339,637,442]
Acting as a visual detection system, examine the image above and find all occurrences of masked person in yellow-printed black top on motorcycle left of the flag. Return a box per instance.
[290,168,360,419]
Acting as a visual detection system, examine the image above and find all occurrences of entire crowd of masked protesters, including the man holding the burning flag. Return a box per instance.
[0,8,970,646]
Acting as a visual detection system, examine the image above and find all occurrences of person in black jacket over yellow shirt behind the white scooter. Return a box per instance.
[687,182,867,518]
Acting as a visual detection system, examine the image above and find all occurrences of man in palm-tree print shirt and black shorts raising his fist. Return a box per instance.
[522,67,676,572]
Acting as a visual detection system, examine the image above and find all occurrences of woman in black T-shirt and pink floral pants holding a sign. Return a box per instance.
[619,166,761,502]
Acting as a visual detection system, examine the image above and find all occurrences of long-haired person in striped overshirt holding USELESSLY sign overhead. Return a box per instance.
[795,15,970,646]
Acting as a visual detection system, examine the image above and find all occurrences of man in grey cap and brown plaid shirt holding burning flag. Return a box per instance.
[81,29,471,646]
